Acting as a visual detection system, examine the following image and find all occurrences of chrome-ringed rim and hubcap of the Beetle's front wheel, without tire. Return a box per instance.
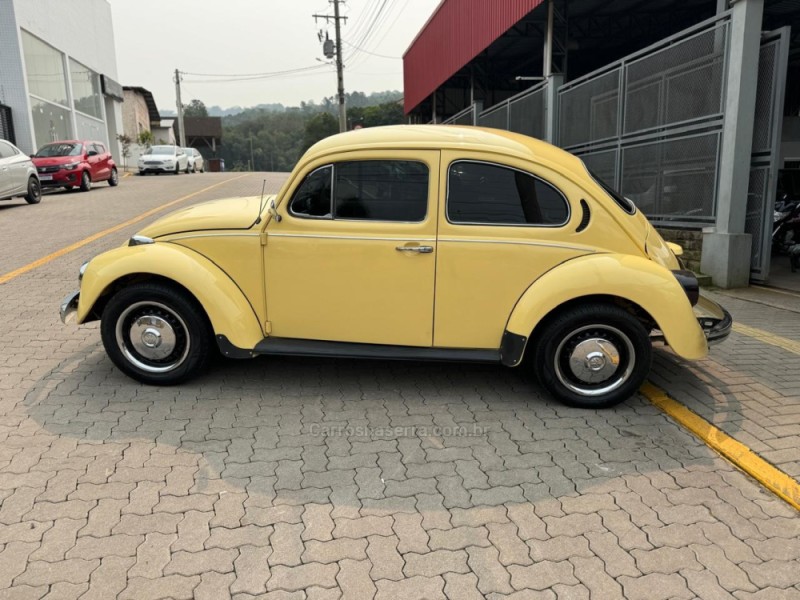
[116,302,191,373]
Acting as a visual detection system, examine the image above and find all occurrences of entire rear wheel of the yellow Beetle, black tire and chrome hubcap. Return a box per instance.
[533,304,653,408]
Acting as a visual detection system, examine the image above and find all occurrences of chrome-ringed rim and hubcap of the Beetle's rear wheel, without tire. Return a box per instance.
[554,325,636,396]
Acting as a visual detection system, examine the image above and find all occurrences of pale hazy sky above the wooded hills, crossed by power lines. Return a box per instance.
[111,0,439,111]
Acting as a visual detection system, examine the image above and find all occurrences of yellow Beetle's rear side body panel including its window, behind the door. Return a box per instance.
[434,151,593,349]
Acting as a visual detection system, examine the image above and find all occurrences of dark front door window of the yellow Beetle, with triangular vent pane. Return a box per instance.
[289,160,429,223]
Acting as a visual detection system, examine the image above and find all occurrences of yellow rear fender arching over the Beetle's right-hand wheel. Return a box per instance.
[506,254,708,360]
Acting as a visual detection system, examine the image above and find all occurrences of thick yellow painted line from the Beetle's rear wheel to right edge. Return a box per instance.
[639,383,800,510]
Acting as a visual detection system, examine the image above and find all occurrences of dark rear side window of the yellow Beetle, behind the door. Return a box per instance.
[447,161,569,226]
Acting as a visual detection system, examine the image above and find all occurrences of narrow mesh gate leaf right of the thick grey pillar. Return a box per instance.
[745,27,790,283]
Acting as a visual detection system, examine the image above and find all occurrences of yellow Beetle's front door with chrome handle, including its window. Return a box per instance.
[264,151,439,347]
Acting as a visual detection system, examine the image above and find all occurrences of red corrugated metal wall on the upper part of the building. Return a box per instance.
[403,0,544,113]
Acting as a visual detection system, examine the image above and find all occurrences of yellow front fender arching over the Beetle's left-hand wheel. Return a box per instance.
[77,242,264,349]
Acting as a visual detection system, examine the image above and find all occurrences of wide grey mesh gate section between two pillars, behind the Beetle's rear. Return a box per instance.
[558,12,730,227]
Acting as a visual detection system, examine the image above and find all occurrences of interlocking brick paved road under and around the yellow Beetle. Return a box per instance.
[0,174,800,600]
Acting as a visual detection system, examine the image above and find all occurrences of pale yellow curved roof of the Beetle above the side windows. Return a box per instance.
[305,125,585,171]
